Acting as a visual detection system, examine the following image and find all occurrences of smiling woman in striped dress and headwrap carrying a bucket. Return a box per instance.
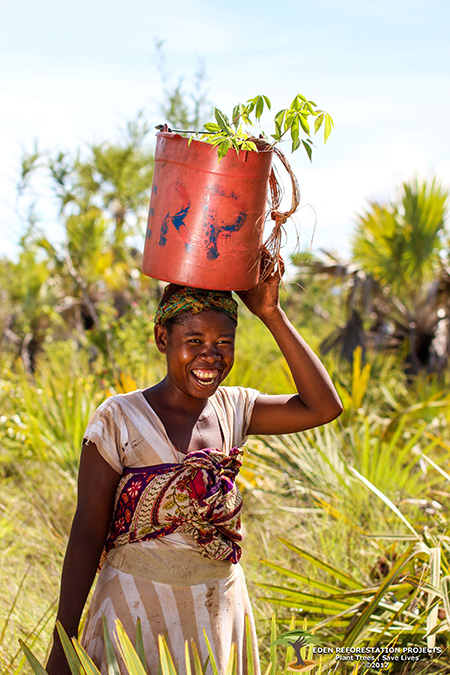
[47,273,342,675]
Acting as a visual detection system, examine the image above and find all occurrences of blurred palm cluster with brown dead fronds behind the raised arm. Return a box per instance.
[296,179,450,373]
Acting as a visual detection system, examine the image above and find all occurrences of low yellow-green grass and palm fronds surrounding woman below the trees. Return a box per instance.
[0,330,450,674]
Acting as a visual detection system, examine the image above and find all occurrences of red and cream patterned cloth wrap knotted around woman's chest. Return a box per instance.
[100,448,243,565]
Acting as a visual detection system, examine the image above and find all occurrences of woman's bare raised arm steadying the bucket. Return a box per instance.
[238,266,342,434]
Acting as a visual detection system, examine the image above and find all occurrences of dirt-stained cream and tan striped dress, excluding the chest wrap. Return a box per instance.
[81,387,259,675]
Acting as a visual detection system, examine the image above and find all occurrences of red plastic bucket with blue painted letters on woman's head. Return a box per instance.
[142,132,273,290]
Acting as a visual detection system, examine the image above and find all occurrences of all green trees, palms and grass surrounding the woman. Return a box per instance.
[0,88,450,675]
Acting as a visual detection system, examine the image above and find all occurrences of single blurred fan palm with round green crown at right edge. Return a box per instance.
[352,179,450,372]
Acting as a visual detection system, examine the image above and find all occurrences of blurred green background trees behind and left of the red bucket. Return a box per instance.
[0,63,212,370]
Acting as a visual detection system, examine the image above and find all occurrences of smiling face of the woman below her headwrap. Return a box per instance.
[155,309,236,398]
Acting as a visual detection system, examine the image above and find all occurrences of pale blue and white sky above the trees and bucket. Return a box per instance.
[0,0,450,257]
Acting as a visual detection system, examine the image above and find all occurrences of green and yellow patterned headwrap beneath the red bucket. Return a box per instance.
[153,285,238,326]
